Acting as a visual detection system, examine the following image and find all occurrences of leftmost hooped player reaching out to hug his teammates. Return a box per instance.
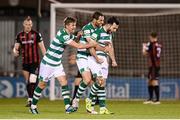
[30,17,97,114]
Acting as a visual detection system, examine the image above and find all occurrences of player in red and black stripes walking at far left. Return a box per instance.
[13,16,46,107]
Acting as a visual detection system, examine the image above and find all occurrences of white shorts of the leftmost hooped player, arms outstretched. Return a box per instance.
[39,63,66,82]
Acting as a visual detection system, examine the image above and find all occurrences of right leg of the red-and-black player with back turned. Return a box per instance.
[152,67,160,104]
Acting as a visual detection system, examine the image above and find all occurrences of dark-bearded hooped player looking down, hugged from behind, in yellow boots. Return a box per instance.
[86,17,119,114]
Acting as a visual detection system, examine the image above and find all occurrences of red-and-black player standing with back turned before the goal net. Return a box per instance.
[143,32,162,104]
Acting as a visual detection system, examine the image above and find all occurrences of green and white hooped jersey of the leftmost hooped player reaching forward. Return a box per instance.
[41,28,75,66]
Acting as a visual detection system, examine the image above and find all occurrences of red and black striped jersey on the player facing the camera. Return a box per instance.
[16,30,42,64]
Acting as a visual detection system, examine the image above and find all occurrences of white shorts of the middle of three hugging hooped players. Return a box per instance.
[76,58,90,74]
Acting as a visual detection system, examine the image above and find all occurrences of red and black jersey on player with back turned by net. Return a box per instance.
[146,41,162,67]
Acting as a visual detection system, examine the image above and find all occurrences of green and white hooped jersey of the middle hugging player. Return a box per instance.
[77,22,96,59]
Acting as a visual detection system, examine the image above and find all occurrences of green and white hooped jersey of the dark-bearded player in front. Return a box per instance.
[91,27,112,57]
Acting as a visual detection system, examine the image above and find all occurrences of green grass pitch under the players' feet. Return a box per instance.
[0,98,180,119]
